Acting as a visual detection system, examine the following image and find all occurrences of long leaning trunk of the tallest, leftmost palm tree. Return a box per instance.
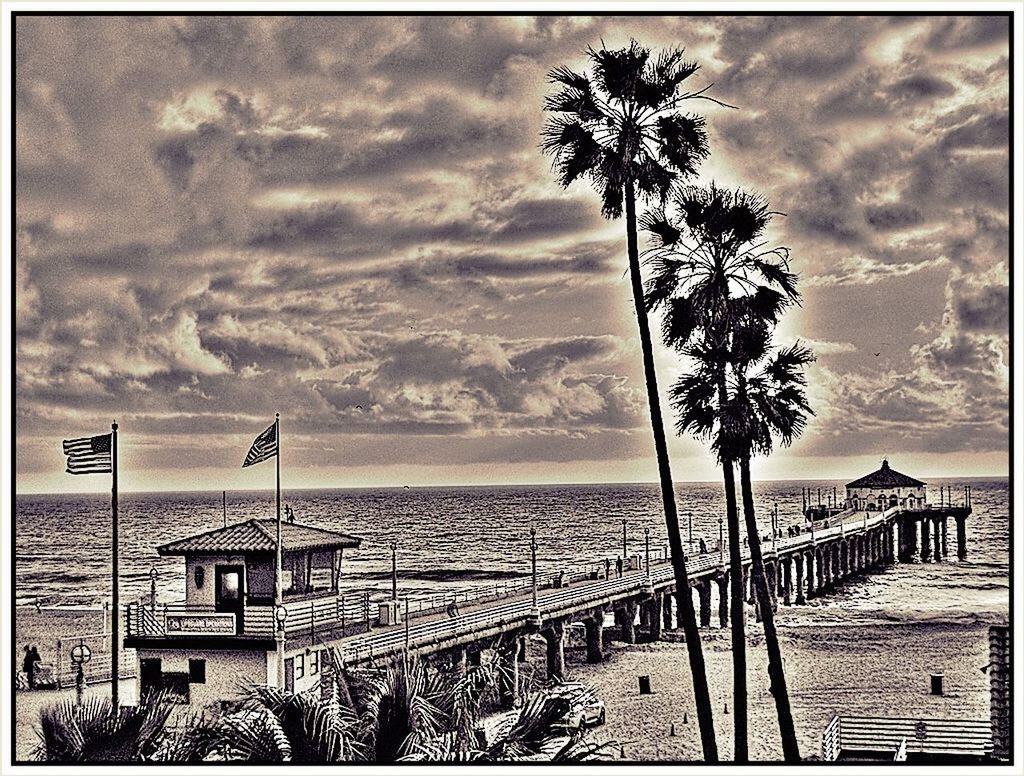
[626,179,718,763]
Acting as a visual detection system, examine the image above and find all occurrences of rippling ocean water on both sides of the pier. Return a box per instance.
[15,478,1010,624]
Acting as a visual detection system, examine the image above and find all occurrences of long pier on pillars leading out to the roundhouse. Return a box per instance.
[310,504,971,677]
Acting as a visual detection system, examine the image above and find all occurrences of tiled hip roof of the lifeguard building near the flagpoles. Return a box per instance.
[157,518,362,555]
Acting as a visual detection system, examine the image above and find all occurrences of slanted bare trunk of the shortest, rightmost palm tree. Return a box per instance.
[739,456,800,763]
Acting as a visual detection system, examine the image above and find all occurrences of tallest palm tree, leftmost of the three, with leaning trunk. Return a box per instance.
[542,41,718,763]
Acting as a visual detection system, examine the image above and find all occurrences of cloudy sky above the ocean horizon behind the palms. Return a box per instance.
[13,16,1010,490]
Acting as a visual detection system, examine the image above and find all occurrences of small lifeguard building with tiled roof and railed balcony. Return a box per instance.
[124,519,368,707]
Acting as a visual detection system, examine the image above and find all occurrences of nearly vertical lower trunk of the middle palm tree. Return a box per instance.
[718,377,750,763]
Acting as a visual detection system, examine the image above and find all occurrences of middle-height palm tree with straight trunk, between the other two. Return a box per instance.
[641,183,799,763]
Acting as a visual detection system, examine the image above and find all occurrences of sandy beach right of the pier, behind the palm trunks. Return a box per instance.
[567,615,989,761]
